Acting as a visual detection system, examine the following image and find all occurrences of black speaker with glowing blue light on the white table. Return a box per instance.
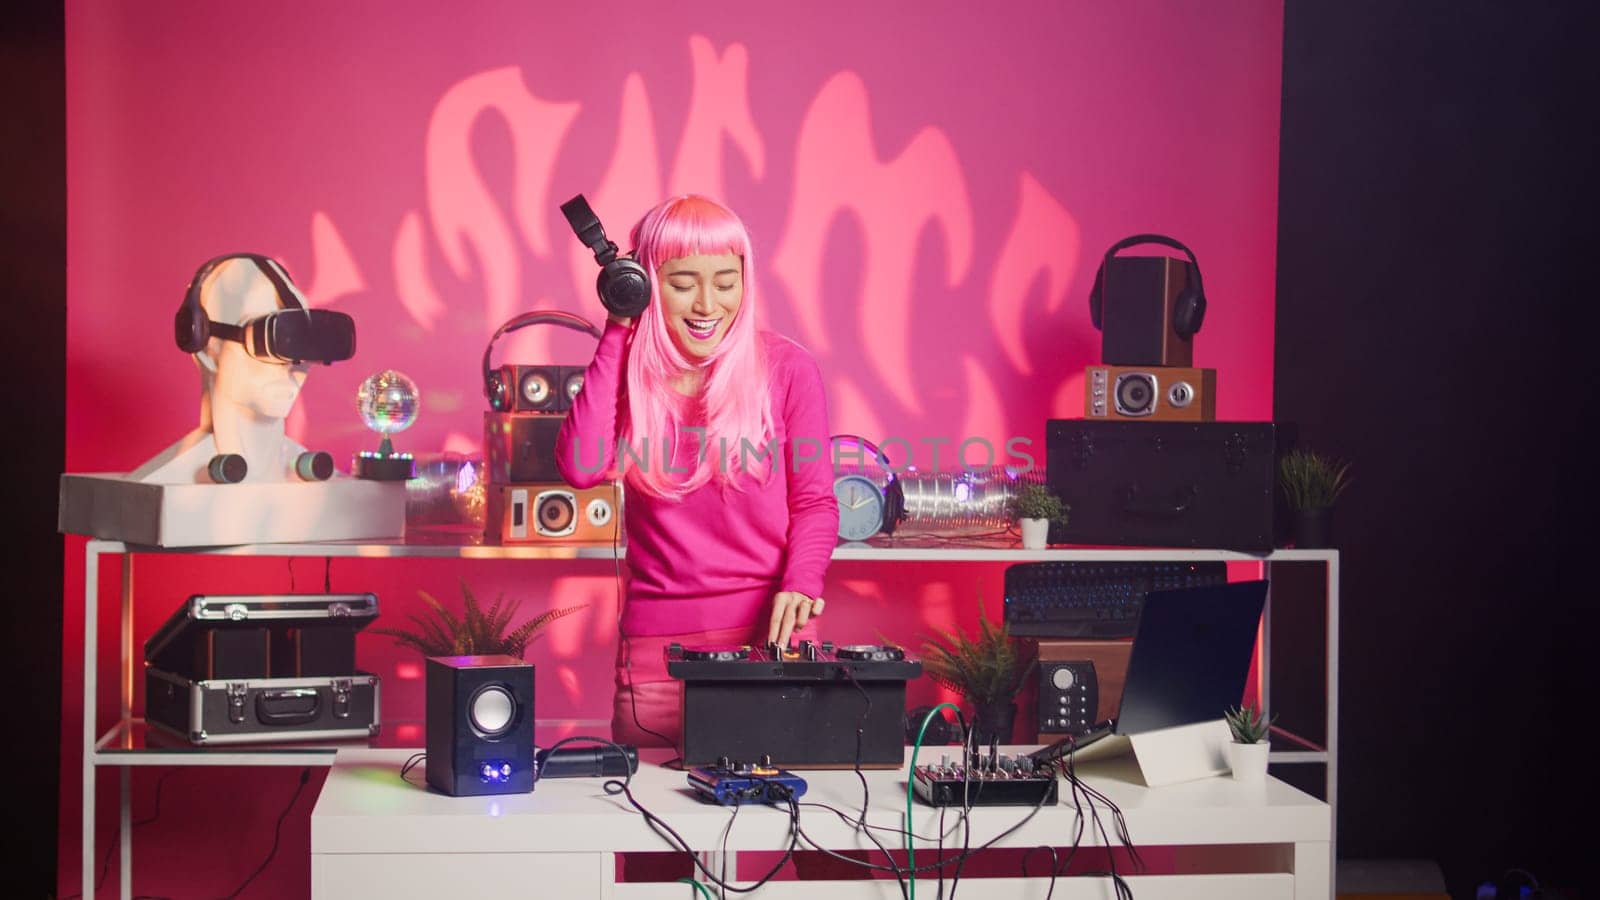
[426,657,534,798]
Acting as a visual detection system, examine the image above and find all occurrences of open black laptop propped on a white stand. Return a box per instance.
[1029,580,1267,762]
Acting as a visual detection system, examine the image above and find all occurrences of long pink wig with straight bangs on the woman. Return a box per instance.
[618,194,781,498]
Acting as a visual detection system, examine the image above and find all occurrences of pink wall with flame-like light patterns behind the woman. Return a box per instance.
[61,0,1282,895]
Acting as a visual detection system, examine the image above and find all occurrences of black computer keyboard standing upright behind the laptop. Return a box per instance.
[1005,562,1227,637]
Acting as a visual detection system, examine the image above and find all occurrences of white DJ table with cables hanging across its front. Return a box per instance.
[310,748,1333,900]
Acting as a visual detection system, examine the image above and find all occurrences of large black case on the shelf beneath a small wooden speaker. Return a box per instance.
[1045,420,1278,552]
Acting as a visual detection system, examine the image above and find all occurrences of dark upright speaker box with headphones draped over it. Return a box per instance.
[1101,256,1194,367]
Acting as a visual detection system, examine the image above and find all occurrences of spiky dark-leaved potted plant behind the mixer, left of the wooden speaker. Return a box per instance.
[922,596,1038,743]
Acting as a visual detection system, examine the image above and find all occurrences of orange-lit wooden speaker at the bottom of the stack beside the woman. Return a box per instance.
[483,482,622,544]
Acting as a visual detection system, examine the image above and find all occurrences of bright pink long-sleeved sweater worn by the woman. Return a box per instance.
[555,322,838,636]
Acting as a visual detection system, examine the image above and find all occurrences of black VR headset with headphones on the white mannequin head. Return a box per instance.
[173,253,355,364]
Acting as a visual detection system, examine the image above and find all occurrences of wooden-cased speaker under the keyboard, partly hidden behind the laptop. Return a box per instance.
[1038,641,1133,743]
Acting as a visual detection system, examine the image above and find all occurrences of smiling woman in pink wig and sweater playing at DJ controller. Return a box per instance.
[555,195,838,746]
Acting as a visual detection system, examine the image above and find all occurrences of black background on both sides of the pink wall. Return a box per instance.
[0,0,1600,897]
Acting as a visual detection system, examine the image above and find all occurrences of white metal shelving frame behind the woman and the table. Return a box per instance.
[82,533,1339,898]
